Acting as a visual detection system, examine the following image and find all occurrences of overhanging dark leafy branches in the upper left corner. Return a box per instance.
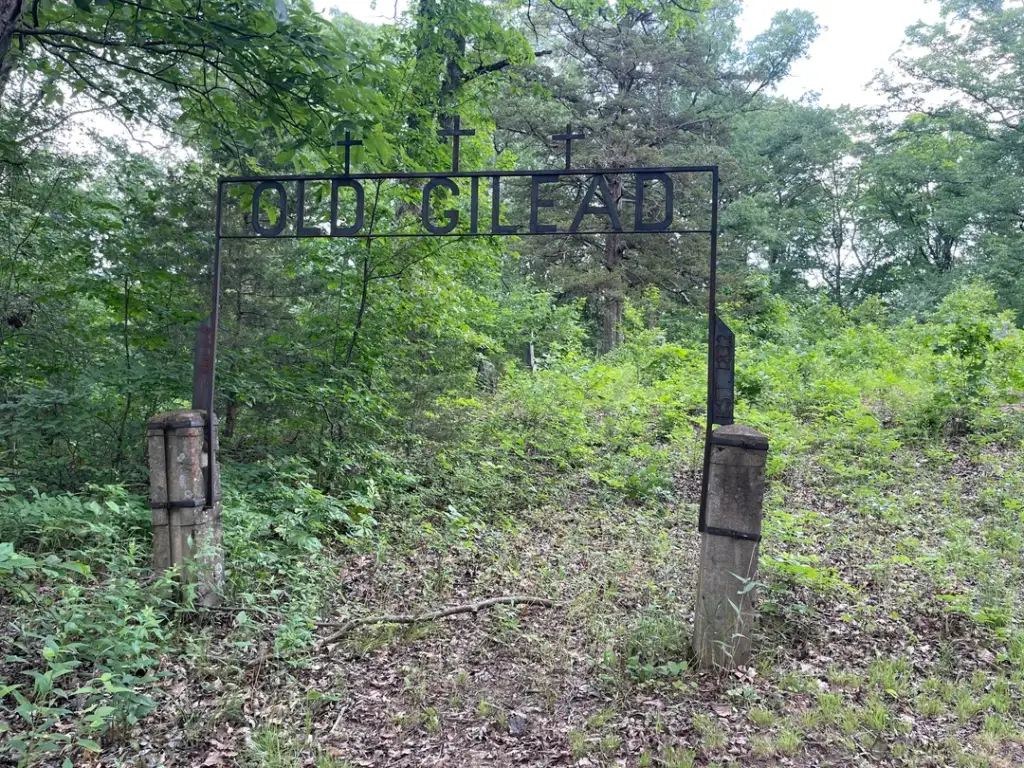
[0,0,378,156]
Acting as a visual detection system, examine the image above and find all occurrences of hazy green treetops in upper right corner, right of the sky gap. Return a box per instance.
[874,0,1024,315]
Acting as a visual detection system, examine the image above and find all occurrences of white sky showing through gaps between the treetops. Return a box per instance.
[331,0,939,106]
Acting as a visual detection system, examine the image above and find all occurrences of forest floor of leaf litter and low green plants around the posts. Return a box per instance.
[0,285,1024,766]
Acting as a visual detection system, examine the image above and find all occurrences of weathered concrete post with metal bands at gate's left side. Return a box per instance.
[147,411,224,605]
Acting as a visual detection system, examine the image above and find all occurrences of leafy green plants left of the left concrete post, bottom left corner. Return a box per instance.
[0,488,172,760]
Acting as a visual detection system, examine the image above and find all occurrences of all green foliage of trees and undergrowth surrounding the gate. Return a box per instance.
[6,0,1024,765]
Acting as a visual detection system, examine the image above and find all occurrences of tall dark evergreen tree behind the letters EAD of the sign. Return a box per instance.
[496,2,817,351]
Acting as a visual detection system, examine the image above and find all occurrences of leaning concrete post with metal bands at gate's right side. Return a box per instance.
[693,424,768,667]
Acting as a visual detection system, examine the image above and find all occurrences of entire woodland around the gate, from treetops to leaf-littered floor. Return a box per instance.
[0,0,1024,768]
